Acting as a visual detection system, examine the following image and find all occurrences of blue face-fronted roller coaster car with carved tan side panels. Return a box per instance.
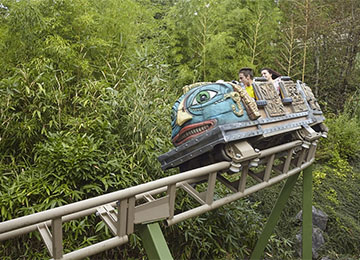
[158,77,328,172]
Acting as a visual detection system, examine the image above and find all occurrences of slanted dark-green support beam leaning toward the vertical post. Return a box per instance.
[250,173,299,260]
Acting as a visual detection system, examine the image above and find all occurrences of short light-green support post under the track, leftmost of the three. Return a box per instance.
[140,223,173,260]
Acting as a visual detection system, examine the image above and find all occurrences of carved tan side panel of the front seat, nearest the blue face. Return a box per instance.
[254,82,285,116]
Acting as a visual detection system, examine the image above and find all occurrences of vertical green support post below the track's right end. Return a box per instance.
[302,165,313,259]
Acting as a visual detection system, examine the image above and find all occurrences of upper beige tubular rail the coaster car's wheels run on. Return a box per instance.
[0,141,302,236]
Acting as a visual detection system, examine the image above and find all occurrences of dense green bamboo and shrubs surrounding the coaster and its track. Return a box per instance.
[0,0,360,259]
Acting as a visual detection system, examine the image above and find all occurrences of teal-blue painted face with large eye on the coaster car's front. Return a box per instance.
[171,83,249,146]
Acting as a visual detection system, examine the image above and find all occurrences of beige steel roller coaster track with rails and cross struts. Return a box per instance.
[0,140,318,259]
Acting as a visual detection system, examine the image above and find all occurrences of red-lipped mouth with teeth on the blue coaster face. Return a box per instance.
[172,120,216,146]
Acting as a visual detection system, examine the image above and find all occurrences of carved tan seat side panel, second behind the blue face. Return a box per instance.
[280,80,307,113]
